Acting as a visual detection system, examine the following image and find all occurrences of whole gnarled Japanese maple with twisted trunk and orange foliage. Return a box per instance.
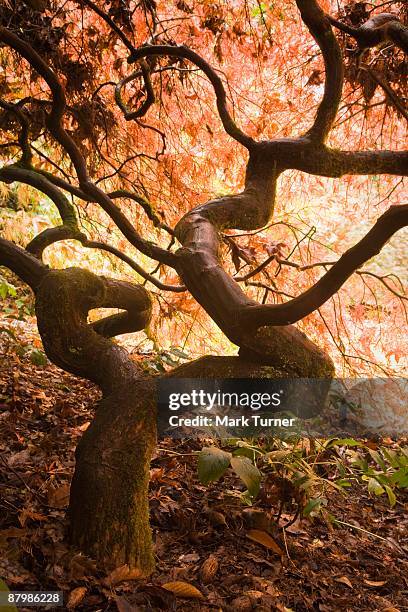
[0,0,408,574]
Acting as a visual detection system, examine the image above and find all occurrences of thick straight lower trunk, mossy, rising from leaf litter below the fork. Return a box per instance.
[69,382,156,576]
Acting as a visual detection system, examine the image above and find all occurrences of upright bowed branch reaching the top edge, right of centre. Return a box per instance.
[296,0,344,142]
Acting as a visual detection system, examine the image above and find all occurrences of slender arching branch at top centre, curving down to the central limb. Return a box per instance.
[128,45,255,149]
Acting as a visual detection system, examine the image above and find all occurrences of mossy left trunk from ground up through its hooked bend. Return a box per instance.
[32,269,156,576]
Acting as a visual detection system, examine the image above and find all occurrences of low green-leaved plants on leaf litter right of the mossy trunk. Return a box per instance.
[198,438,408,525]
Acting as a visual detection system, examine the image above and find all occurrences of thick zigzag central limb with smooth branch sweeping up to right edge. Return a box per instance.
[175,142,408,354]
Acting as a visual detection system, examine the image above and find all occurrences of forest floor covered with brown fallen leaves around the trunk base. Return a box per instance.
[0,298,408,612]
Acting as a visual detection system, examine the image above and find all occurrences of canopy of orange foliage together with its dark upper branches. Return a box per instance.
[1,1,407,372]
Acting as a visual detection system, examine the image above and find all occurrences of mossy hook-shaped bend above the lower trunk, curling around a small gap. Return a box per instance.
[36,268,150,396]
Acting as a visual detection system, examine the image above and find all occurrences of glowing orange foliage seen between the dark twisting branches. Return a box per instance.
[0,0,408,374]
